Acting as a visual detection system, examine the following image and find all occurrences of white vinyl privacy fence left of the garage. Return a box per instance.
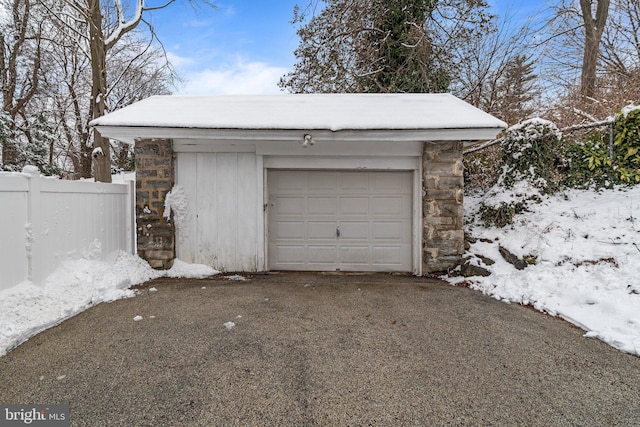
[0,173,135,291]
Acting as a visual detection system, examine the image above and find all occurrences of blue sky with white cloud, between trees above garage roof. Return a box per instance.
[147,0,544,94]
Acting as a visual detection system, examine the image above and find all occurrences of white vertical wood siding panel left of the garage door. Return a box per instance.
[176,152,264,271]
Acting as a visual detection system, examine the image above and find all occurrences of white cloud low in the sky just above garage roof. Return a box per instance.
[178,59,288,95]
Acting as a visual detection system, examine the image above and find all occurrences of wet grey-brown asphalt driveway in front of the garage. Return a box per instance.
[0,274,640,426]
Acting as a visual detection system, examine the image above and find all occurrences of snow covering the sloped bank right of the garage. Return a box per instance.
[446,186,640,356]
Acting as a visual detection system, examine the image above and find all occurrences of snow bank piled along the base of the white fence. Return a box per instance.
[0,252,218,356]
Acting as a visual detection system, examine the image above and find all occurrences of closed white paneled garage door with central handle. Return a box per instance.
[267,170,412,272]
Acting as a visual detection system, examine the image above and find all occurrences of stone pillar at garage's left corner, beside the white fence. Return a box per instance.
[134,139,176,268]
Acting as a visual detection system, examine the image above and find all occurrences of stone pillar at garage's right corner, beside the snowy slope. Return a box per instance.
[422,141,464,274]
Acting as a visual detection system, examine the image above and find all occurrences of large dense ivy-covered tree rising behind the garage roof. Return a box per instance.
[279,0,493,93]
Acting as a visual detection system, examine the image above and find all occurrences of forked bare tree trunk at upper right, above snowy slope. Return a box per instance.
[580,0,610,100]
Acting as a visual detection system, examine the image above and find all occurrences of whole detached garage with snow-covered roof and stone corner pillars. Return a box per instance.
[91,94,506,275]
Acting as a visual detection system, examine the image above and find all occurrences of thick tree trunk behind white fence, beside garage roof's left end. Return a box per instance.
[87,0,111,182]
